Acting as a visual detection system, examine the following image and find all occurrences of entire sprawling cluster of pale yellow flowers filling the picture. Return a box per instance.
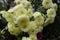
[0,0,57,40]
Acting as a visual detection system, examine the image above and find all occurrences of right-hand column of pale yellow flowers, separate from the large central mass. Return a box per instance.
[42,0,58,26]
